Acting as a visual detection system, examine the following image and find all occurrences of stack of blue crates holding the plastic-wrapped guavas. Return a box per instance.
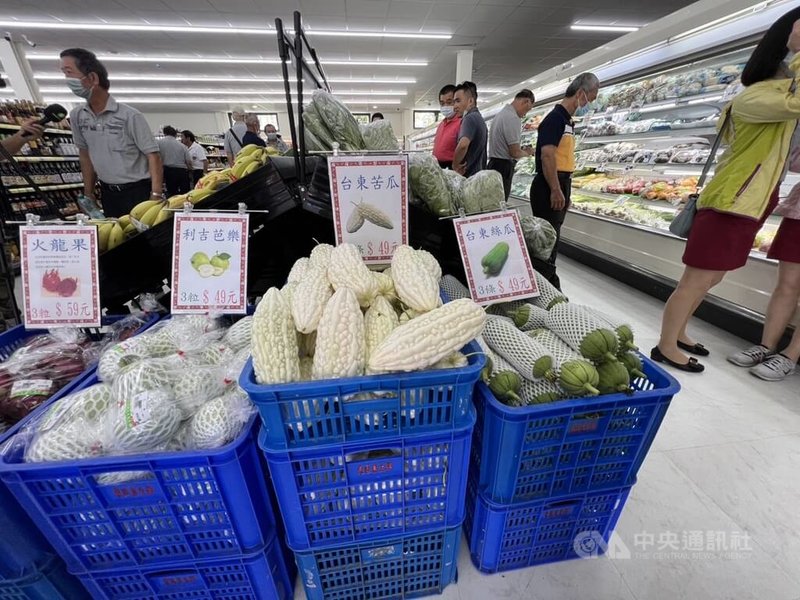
[0,316,295,600]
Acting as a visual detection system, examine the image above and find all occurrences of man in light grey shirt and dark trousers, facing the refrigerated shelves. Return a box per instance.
[487,89,534,200]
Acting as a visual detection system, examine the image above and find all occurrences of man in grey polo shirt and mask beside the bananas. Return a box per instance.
[61,48,164,217]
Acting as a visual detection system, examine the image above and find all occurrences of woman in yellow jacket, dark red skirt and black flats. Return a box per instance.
[650,8,800,373]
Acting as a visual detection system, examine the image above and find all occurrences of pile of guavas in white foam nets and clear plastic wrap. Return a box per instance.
[9,316,254,464]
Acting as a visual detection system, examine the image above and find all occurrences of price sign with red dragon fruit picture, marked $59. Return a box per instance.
[20,225,101,327]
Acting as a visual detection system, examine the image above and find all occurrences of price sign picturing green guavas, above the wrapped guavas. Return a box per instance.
[171,213,250,314]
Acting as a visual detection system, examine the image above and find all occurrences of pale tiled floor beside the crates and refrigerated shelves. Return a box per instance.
[297,259,800,600]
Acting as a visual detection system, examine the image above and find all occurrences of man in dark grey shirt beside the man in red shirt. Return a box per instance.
[453,81,488,177]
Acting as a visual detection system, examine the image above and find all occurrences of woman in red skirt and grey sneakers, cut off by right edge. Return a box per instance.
[728,180,800,381]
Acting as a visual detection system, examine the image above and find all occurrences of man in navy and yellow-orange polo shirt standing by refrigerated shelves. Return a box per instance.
[530,73,600,289]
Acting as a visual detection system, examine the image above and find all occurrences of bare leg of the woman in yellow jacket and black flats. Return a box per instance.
[658,267,725,363]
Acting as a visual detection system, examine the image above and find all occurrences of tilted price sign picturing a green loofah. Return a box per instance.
[453,210,539,304]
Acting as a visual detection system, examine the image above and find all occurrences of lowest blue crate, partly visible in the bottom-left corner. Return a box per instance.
[0,556,90,600]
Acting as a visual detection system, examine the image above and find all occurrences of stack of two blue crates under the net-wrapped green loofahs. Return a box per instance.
[464,357,680,573]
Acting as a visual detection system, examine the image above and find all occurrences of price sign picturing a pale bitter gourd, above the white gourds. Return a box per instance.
[328,155,408,264]
